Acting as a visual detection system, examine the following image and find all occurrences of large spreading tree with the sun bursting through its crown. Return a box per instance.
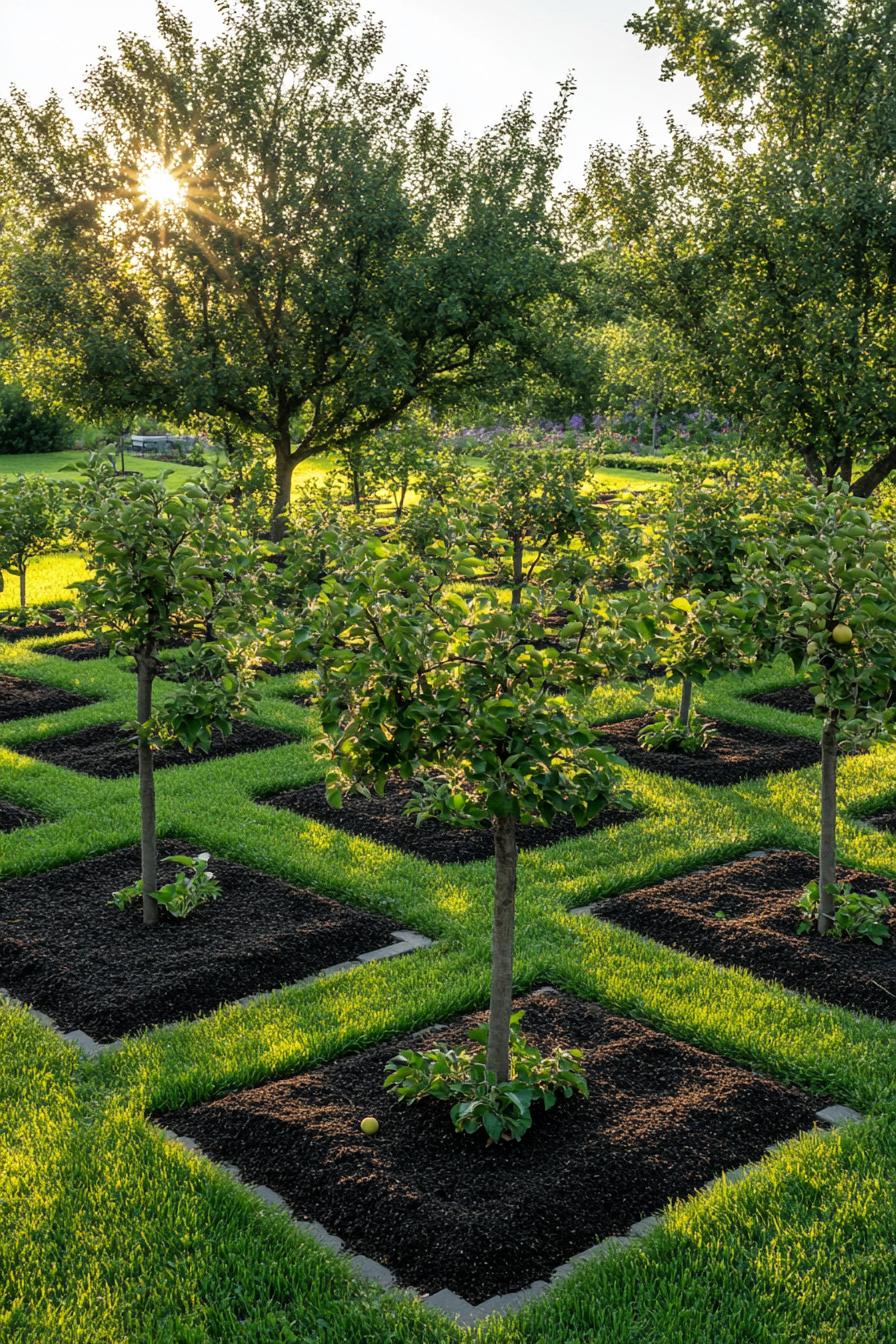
[0,0,570,531]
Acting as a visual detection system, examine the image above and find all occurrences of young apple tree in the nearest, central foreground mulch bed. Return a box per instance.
[312,524,638,1137]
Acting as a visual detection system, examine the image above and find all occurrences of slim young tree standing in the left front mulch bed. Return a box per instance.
[75,456,266,925]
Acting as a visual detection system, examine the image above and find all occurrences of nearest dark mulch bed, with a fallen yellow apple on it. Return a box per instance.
[159,992,823,1302]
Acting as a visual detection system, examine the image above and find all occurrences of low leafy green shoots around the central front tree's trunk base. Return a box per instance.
[383,1012,588,1144]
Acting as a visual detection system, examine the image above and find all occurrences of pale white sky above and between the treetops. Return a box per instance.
[0,0,695,180]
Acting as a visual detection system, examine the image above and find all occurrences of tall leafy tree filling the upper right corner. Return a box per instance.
[579,0,896,496]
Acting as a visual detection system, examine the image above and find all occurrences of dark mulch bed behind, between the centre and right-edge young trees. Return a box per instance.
[600,714,821,785]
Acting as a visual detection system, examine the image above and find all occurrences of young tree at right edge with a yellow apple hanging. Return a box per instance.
[748,482,896,933]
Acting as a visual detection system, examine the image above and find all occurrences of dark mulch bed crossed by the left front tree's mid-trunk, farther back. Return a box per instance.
[16,719,293,780]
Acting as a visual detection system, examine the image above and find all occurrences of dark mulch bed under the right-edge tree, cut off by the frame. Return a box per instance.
[592,849,896,1019]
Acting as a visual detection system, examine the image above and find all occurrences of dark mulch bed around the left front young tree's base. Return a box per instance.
[0,840,396,1040]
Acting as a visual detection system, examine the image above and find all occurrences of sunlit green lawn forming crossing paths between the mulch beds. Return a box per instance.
[0,615,896,1344]
